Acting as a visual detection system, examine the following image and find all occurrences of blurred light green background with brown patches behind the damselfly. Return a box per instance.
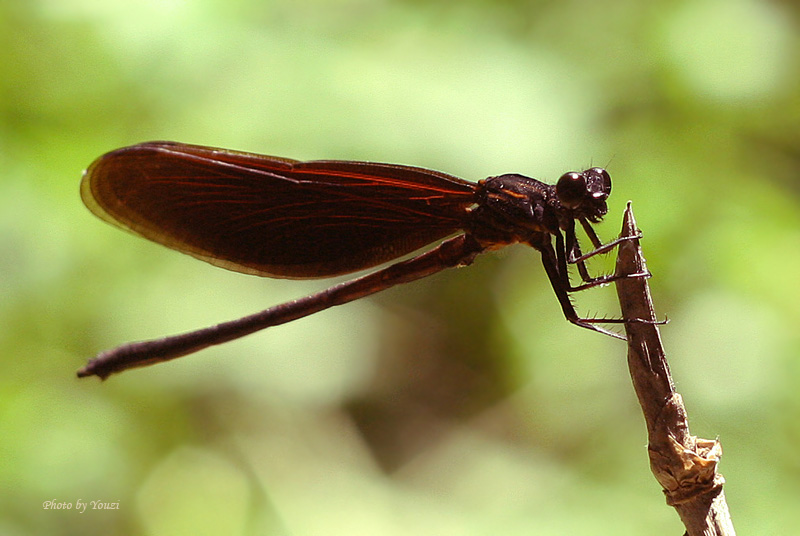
[0,0,800,536]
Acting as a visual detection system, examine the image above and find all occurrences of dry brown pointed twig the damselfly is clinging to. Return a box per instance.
[616,203,735,536]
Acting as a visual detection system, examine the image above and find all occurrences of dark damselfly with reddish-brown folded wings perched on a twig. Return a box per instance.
[78,142,644,378]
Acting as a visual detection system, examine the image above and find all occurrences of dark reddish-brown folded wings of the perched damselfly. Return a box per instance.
[81,142,476,278]
